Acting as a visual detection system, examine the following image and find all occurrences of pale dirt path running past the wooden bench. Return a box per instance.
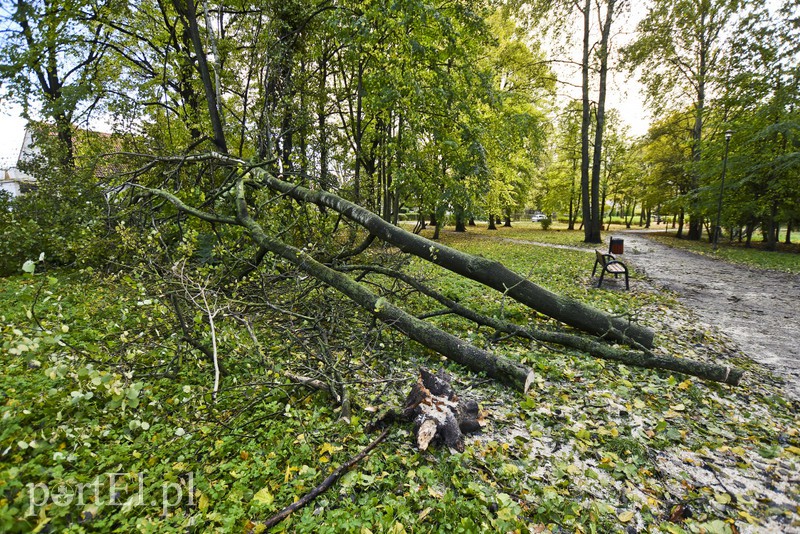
[615,231,800,400]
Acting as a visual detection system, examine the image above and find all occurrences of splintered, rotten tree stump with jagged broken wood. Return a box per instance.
[402,367,485,452]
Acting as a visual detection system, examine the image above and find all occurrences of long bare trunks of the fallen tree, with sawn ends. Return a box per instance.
[132,163,742,392]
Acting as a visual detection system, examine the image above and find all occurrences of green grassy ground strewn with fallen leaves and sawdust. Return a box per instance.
[0,230,800,532]
